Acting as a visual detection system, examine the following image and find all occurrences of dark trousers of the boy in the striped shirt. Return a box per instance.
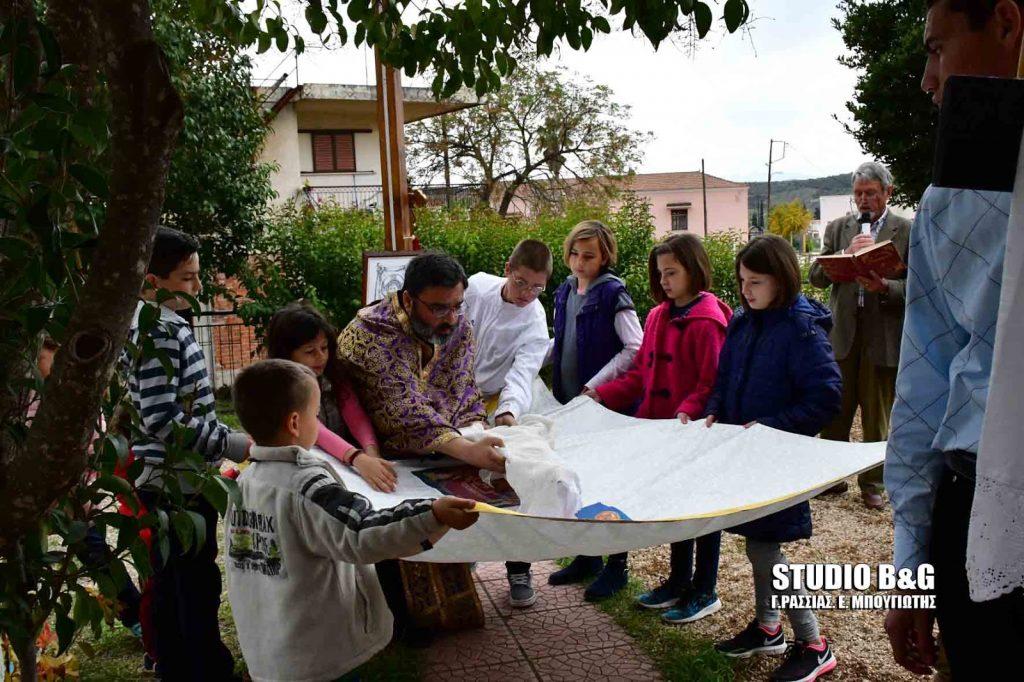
[139,491,234,681]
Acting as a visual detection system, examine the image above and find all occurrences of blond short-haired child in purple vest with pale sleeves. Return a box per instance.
[548,220,643,599]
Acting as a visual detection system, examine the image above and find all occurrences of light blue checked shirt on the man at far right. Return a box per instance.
[885,187,1011,567]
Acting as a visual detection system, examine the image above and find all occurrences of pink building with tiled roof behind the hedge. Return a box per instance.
[625,171,750,237]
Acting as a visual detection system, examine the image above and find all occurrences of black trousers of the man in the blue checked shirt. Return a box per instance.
[931,467,1024,680]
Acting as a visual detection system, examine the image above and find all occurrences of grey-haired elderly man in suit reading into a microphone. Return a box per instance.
[809,162,910,509]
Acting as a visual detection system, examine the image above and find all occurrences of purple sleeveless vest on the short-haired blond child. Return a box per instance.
[552,278,633,402]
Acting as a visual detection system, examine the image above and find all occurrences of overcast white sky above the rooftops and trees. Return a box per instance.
[247,0,888,181]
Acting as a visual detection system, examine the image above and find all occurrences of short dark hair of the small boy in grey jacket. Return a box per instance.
[231,358,316,445]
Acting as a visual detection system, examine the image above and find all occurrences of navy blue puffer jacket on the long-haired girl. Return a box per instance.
[707,294,843,542]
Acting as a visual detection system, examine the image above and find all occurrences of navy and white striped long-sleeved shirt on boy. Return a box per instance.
[125,301,249,471]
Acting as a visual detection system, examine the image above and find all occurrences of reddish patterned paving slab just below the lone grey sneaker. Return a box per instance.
[506,604,633,658]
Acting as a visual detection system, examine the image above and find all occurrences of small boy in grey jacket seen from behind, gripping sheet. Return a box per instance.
[225,359,477,680]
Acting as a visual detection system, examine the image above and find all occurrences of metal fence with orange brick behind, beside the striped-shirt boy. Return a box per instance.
[190,310,261,393]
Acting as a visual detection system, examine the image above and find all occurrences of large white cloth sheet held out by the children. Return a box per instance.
[307,383,886,561]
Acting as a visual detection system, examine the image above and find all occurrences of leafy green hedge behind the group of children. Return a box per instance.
[243,200,826,327]
